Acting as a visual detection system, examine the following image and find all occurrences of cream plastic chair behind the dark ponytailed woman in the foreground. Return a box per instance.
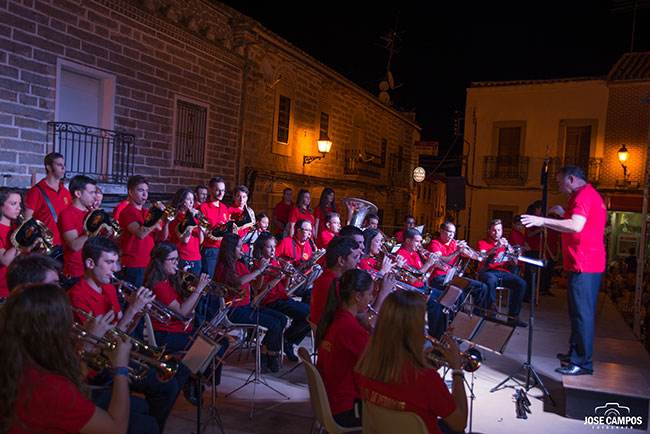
[298,347,360,434]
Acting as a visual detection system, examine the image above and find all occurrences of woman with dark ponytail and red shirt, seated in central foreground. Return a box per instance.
[314,269,373,427]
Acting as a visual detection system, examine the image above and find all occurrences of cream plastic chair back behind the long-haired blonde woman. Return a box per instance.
[361,401,429,434]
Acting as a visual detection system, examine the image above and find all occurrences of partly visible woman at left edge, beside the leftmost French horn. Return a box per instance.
[0,187,22,298]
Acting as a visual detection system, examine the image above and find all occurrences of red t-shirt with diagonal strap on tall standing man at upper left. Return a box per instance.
[25,179,72,246]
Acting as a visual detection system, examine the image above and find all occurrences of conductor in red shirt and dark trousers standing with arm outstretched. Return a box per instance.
[521,166,607,375]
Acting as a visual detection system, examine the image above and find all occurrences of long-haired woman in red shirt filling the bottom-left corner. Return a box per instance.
[0,284,130,433]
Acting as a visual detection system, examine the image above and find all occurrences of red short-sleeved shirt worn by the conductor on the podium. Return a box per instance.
[562,184,607,273]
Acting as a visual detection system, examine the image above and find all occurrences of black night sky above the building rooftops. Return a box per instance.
[219,0,650,172]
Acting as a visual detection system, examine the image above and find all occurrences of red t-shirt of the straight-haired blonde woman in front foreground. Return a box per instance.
[355,363,456,434]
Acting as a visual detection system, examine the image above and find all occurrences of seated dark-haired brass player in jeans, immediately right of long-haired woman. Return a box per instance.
[253,232,310,362]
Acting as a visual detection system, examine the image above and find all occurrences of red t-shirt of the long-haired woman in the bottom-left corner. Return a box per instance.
[9,366,95,434]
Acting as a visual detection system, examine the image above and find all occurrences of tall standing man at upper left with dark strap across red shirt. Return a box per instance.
[25,152,72,246]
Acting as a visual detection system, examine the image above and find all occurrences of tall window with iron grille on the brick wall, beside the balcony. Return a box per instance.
[174,99,208,169]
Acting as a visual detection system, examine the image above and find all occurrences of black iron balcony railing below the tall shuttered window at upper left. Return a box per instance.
[47,122,135,184]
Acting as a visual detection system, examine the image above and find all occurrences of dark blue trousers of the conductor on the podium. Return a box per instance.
[567,271,603,371]
